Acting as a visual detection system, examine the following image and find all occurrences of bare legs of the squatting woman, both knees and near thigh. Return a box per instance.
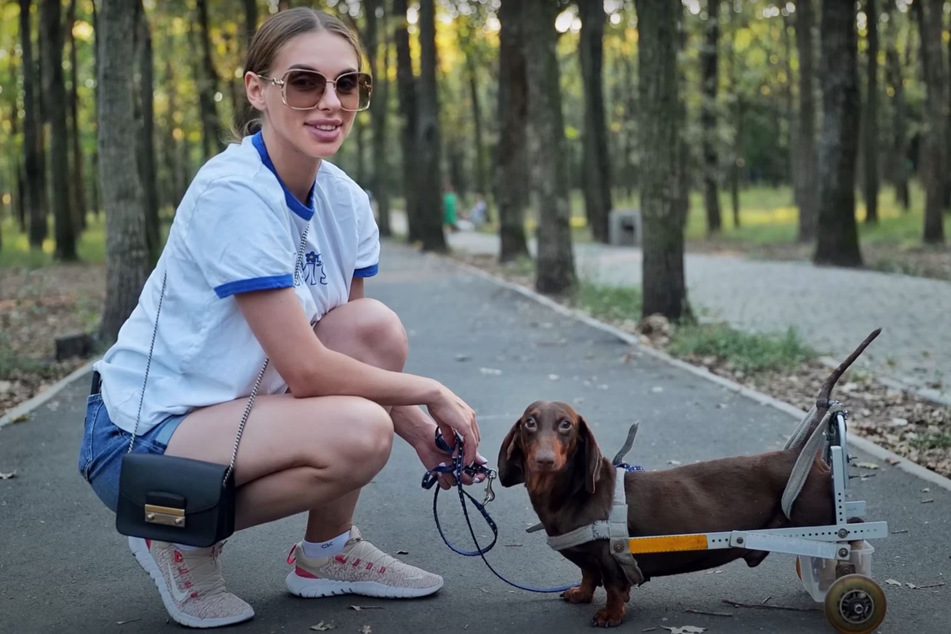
[166,299,407,541]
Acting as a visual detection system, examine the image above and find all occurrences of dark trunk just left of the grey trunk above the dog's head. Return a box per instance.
[494,0,529,262]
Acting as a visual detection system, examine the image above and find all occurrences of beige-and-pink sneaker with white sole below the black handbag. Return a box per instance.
[129,537,254,627]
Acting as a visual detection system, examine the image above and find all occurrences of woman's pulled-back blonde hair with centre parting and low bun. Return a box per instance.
[232,7,364,142]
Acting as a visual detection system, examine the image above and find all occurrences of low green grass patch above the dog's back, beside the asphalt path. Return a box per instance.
[668,323,816,372]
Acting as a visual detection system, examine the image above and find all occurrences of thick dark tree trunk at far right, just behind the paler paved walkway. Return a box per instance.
[813,2,862,266]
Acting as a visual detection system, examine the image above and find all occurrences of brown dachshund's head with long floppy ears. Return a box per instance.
[498,401,603,493]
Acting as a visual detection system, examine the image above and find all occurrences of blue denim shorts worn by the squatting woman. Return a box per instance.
[79,394,186,512]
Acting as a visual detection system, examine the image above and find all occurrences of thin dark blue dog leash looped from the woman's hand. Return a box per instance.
[423,428,578,593]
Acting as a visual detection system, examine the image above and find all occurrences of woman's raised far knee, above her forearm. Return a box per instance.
[316,298,409,371]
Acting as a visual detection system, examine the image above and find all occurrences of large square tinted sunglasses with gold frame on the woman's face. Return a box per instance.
[258,68,373,112]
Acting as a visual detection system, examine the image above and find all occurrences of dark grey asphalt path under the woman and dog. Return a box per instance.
[0,239,951,634]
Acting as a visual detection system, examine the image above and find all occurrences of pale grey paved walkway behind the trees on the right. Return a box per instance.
[449,232,951,404]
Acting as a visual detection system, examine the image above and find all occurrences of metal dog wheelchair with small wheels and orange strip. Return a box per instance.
[615,402,888,634]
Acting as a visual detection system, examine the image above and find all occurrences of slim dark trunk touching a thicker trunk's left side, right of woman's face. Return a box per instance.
[393,0,422,243]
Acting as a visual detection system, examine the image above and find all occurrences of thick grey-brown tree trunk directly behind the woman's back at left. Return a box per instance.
[99,0,148,342]
